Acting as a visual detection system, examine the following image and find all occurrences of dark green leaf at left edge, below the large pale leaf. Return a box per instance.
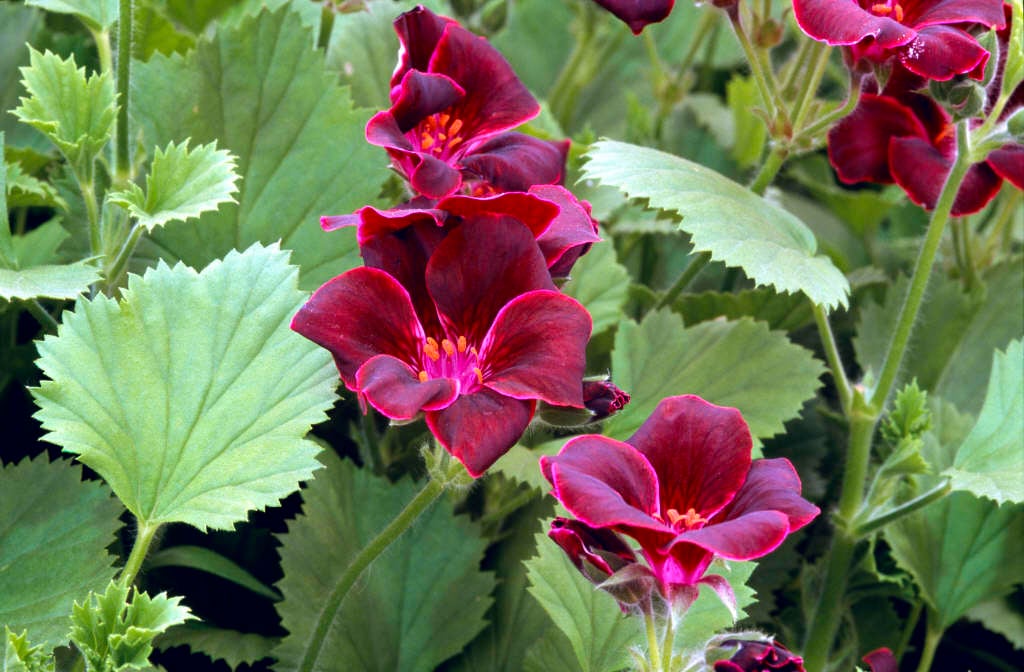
[0,457,122,650]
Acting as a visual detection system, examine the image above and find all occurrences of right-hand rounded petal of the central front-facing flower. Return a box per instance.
[480,290,592,408]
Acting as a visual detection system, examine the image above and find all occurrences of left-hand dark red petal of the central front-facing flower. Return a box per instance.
[292,267,424,389]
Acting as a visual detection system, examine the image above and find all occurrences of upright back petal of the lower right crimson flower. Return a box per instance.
[626,394,753,518]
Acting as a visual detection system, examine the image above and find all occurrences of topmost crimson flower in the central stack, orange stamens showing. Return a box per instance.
[367,6,568,199]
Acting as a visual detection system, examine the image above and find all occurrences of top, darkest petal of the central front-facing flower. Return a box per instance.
[426,218,552,346]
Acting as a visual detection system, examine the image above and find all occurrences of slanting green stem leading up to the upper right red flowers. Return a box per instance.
[871,121,971,410]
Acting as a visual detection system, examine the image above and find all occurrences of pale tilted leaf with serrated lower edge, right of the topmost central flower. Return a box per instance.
[583,140,850,307]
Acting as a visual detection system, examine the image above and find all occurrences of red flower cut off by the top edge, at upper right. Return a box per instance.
[793,0,1005,81]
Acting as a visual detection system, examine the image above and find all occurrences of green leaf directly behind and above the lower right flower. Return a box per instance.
[605,310,824,446]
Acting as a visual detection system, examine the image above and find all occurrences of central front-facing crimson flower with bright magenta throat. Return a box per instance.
[292,219,591,476]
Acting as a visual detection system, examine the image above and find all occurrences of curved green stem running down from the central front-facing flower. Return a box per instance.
[299,479,444,672]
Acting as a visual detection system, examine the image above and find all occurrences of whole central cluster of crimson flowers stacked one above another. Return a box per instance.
[292,6,599,476]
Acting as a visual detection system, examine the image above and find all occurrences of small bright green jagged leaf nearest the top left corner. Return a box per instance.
[13,46,117,174]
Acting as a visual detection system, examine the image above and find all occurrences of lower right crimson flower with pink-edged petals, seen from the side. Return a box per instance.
[541,395,819,607]
